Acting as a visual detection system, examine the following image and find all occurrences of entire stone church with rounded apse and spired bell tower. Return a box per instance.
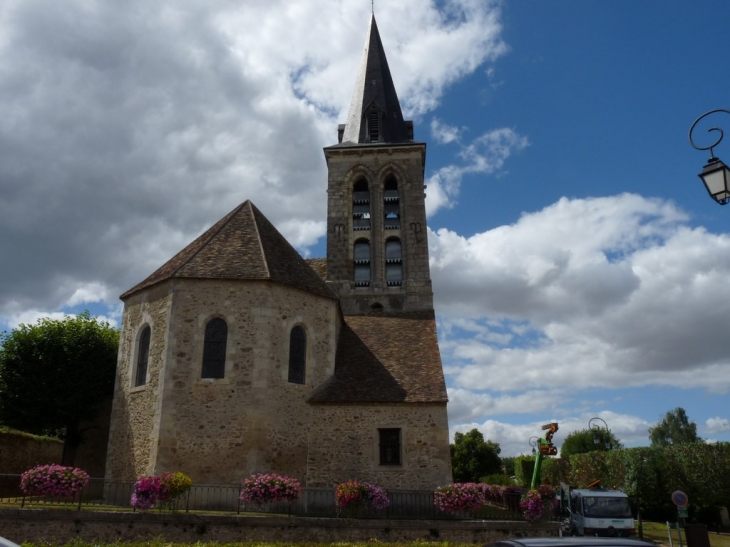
[106,16,452,489]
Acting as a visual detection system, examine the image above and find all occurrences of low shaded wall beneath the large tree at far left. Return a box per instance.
[0,431,63,475]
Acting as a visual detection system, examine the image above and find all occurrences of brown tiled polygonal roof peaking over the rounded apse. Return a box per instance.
[121,201,337,298]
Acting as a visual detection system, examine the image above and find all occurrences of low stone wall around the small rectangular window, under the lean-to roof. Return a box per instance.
[302,403,452,490]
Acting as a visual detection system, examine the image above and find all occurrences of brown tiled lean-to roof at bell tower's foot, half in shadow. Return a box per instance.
[309,311,448,403]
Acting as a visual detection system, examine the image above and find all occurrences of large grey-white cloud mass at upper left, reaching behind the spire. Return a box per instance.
[0,0,506,322]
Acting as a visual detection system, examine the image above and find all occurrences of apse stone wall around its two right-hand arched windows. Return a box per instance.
[153,280,341,484]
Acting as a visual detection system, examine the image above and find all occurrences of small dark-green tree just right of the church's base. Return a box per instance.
[451,428,502,482]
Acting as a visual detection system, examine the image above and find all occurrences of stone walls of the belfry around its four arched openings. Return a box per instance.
[325,144,433,315]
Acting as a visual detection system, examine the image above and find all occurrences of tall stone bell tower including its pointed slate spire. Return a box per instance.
[324,15,433,315]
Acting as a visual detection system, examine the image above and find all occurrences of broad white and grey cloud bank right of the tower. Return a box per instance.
[429,194,730,400]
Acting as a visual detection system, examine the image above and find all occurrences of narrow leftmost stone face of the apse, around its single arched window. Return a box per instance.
[106,281,172,481]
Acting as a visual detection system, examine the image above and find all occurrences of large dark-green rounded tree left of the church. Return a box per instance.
[0,312,119,465]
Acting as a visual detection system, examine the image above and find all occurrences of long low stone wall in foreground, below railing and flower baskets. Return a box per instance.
[0,509,559,544]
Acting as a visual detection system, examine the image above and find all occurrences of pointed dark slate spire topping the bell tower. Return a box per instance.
[340,14,413,143]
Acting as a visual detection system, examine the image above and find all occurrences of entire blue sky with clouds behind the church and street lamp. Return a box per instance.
[0,0,730,455]
